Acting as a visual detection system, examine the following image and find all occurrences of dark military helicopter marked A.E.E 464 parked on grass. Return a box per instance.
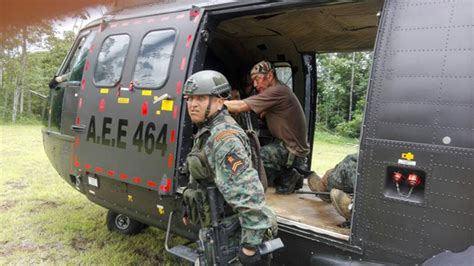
[42,0,474,265]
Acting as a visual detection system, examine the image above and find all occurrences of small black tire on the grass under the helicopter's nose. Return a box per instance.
[106,210,148,235]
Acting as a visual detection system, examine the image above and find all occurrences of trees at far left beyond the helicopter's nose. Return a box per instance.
[0,23,75,123]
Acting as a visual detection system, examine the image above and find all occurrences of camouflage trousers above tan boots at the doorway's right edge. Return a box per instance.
[327,153,357,193]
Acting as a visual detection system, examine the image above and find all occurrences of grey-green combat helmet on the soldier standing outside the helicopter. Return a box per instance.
[183,70,231,98]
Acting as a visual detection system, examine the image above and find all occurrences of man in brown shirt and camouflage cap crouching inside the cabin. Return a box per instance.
[224,61,309,194]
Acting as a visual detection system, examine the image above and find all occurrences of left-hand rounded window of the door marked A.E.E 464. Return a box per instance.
[94,34,130,87]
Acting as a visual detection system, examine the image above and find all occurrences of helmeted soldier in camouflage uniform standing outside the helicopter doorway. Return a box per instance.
[183,70,276,263]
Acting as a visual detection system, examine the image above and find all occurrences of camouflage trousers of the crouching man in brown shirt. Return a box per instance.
[260,141,306,185]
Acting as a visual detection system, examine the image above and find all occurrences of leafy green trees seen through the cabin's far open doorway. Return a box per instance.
[316,52,371,137]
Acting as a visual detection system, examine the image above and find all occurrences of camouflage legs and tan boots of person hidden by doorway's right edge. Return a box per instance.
[308,153,357,220]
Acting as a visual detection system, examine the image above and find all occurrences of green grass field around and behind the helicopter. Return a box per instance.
[0,125,357,265]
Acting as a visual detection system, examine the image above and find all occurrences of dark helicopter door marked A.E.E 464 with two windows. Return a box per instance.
[71,9,201,196]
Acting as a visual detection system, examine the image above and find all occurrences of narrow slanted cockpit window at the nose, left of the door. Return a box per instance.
[63,30,97,82]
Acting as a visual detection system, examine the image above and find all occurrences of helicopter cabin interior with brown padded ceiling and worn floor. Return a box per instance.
[197,1,383,240]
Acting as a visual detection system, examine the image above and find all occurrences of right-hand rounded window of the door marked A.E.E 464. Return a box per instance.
[133,30,176,88]
